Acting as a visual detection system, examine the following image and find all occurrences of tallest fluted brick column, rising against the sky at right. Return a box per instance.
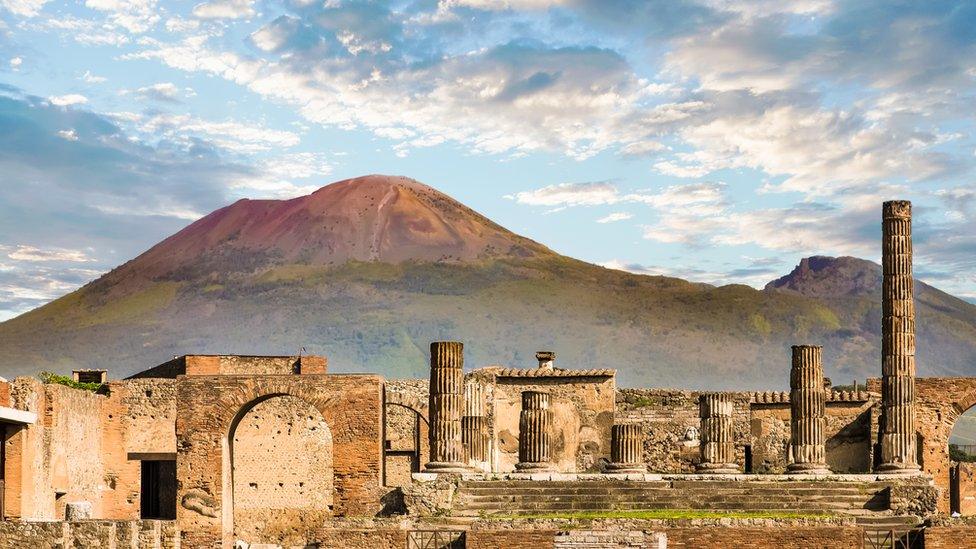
[878,200,919,474]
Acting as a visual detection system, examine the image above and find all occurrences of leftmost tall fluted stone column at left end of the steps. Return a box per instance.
[424,341,467,473]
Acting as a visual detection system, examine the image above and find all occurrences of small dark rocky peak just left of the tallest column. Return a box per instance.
[765,255,881,298]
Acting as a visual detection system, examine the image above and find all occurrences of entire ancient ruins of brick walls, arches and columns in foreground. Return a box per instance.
[0,202,976,549]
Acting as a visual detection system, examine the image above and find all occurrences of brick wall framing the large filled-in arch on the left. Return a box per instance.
[176,375,384,546]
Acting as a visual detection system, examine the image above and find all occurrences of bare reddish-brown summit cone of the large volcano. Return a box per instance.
[113,175,552,284]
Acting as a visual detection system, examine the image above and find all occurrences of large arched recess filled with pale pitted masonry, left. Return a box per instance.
[229,395,334,545]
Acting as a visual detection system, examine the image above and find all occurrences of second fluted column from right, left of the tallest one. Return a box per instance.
[787,345,830,475]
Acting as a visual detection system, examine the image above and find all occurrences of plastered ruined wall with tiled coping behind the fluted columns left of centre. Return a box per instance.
[487,376,616,472]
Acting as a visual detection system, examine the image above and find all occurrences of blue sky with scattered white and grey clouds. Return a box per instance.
[0,0,976,320]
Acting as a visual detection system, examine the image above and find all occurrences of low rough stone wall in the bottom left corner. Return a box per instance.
[0,520,180,549]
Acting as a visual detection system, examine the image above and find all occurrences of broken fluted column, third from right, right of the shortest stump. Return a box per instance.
[696,393,740,474]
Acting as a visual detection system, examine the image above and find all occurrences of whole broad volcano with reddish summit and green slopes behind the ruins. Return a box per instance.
[0,176,976,389]
